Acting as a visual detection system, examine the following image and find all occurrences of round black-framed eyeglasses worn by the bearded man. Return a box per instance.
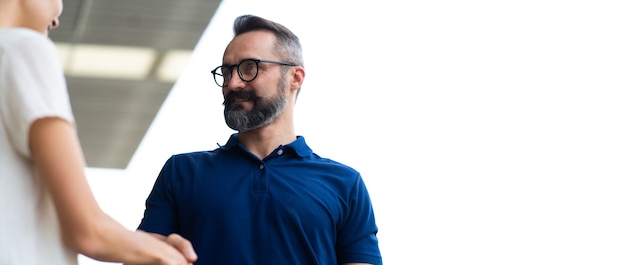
[211,59,296,87]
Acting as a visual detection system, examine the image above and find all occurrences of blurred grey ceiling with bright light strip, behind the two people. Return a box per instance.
[50,0,220,169]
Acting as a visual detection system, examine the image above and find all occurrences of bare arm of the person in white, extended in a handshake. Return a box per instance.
[29,118,196,264]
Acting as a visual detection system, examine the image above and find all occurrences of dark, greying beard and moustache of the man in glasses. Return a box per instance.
[224,82,287,132]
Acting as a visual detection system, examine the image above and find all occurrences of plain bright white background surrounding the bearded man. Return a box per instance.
[80,0,626,265]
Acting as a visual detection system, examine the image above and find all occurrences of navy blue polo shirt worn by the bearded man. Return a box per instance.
[138,133,382,265]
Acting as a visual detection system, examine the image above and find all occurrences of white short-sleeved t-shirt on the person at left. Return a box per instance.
[0,28,78,265]
